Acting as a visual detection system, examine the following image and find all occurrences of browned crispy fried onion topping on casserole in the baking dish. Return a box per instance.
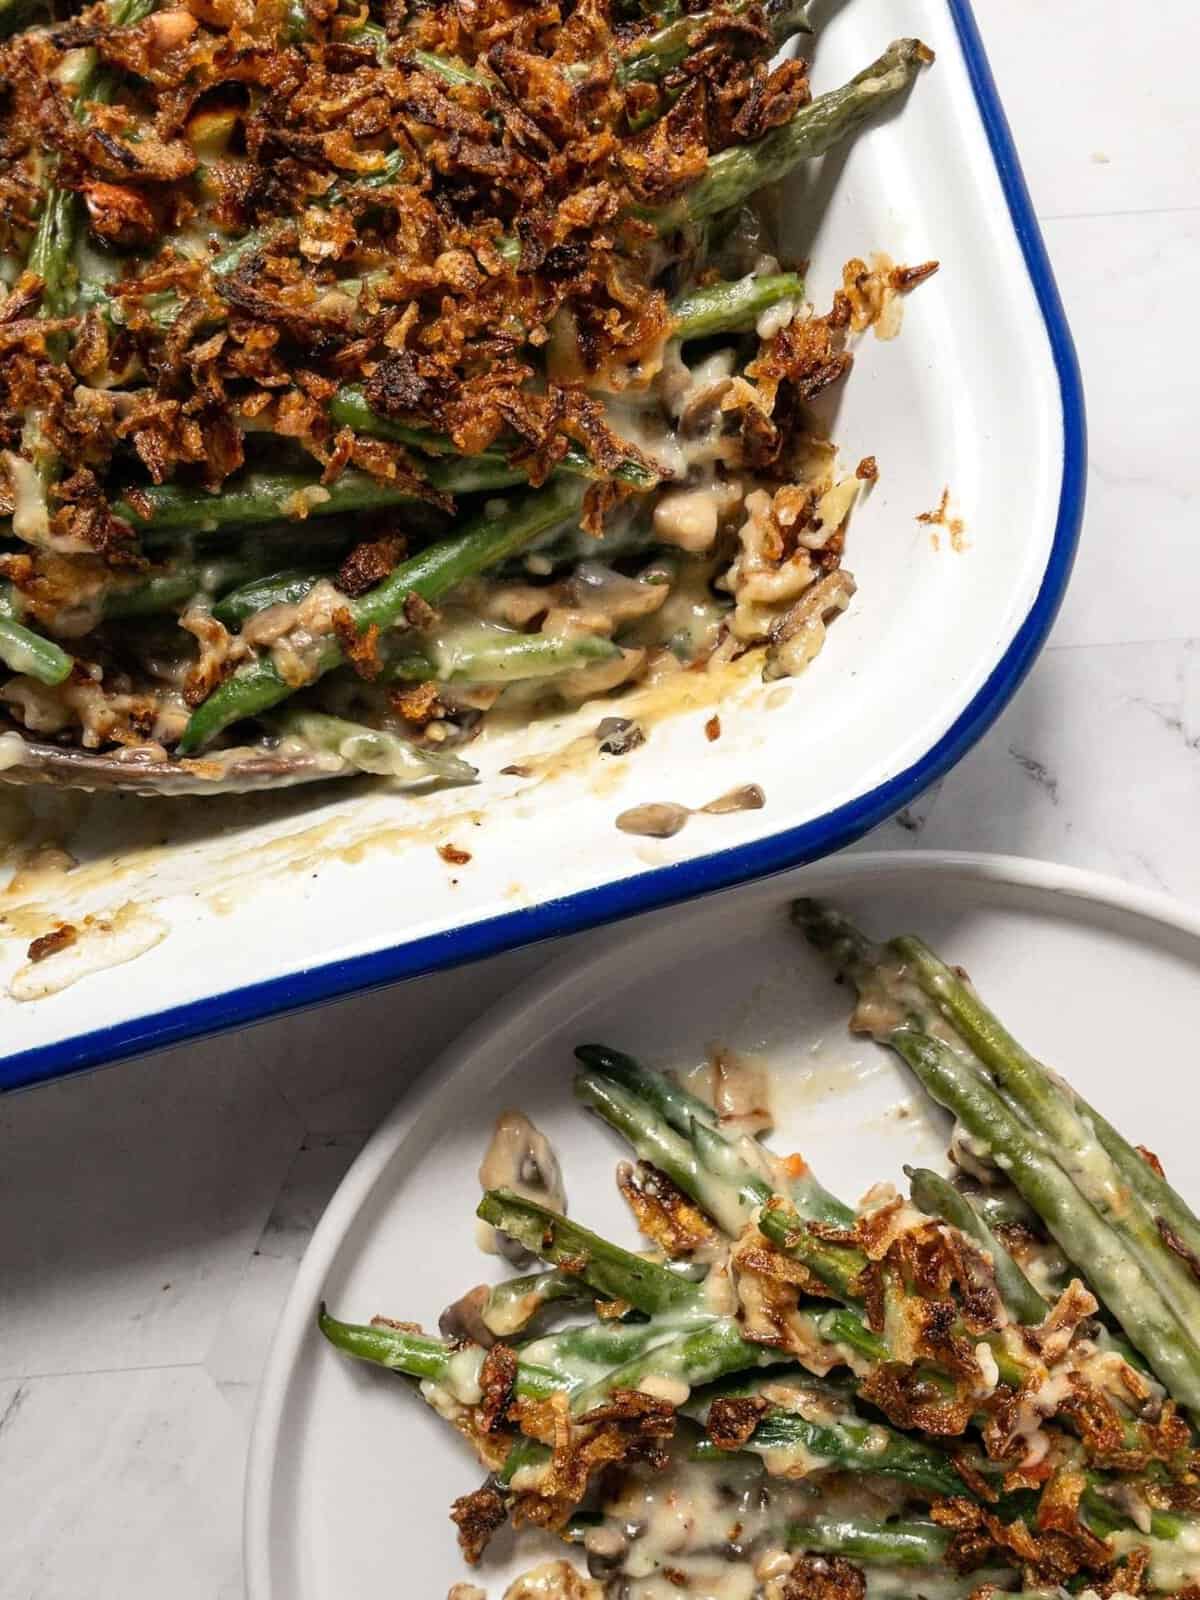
[0,0,850,550]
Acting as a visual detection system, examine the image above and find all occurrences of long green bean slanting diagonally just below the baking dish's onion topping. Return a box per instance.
[179,480,581,755]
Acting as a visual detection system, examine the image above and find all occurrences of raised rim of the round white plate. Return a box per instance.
[242,850,1200,1600]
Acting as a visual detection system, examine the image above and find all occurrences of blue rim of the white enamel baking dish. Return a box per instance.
[0,0,1086,1091]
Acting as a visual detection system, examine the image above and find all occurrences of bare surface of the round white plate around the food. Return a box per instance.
[245,854,1200,1600]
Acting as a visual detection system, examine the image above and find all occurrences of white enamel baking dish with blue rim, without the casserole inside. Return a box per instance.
[0,0,1083,1086]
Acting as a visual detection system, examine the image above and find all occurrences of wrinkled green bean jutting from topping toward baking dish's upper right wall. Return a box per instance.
[649,38,931,234]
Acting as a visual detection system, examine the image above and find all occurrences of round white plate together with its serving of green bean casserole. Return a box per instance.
[245,851,1200,1600]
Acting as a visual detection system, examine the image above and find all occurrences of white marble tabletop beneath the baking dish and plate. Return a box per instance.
[0,0,1200,1600]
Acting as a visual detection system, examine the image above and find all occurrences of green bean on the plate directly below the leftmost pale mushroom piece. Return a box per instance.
[475,1189,704,1315]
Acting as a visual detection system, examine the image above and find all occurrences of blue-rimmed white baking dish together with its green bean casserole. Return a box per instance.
[0,0,1082,1083]
